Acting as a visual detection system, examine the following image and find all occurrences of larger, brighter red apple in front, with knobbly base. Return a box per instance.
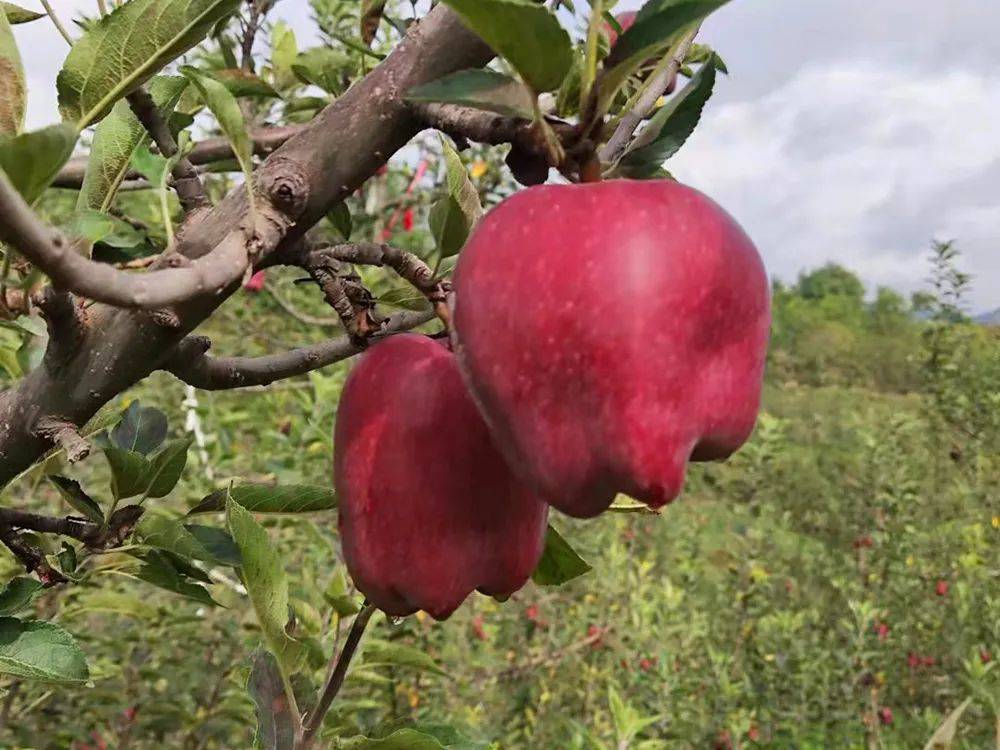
[454,180,770,518]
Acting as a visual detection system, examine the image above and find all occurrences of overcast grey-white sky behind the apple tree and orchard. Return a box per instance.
[16,0,1000,311]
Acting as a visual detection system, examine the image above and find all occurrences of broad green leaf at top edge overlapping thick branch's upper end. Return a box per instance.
[444,0,573,94]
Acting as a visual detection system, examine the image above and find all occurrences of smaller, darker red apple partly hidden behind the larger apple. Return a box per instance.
[334,334,548,620]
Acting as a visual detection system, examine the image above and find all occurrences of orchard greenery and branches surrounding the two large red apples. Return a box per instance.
[0,0,1000,750]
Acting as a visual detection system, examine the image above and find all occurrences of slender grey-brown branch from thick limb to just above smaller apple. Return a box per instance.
[162,312,434,391]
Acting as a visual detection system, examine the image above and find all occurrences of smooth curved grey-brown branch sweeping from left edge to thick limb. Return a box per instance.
[0,174,249,308]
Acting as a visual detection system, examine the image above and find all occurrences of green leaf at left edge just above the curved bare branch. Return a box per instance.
[0,124,78,203]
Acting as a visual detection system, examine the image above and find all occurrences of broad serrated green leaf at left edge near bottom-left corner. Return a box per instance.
[0,617,90,684]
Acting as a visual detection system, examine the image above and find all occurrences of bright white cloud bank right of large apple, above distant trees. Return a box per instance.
[670,60,1000,309]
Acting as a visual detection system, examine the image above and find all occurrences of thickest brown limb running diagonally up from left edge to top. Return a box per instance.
[0,5,493,485]
